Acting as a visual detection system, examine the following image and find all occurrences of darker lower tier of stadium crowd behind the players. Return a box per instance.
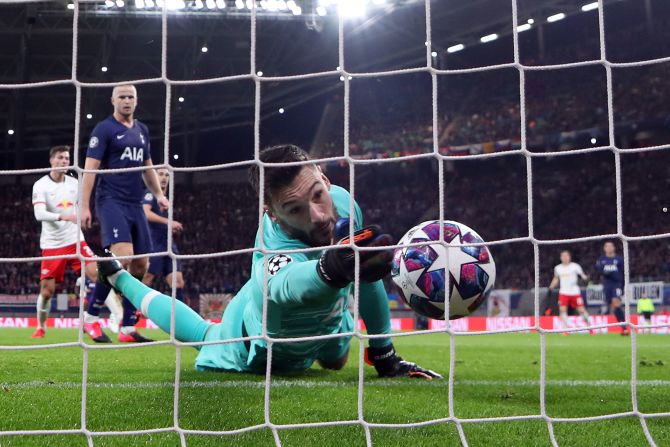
[0,146,670,297]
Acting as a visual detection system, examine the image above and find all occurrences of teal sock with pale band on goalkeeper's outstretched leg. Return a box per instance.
[108,271,210,342]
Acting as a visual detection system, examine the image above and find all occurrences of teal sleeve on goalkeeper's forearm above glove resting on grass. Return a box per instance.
[359,281,391,348]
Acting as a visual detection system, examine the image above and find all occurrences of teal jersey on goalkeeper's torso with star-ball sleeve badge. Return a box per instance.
[196,185,372,372]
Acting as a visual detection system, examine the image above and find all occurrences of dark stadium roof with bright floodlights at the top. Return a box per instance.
[0,0,652,167]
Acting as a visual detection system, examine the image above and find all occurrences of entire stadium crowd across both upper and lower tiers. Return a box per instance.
[0,12,670,302]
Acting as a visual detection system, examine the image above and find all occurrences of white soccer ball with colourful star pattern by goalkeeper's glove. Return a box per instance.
[391,220,496,320]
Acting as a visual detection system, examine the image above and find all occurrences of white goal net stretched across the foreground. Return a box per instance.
[0,0,670,446]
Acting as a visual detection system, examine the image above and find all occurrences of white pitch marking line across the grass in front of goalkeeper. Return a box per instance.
[0,379,670,390]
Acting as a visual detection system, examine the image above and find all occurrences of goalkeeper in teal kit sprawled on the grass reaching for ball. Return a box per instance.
[93,145,442,379]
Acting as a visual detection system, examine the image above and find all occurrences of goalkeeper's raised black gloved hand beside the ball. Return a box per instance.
[316,219,393,289]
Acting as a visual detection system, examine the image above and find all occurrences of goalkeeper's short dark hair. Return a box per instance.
[249,144,310,204]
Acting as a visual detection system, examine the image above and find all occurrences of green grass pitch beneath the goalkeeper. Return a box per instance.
[0,329,670,447]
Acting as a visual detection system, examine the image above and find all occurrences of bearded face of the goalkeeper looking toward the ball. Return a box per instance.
[268,166,337,247]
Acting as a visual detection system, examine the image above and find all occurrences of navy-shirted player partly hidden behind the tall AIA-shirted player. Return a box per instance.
[142,168,184,301]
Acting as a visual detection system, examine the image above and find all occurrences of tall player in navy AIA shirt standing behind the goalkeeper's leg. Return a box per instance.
[81,84,169,343]
